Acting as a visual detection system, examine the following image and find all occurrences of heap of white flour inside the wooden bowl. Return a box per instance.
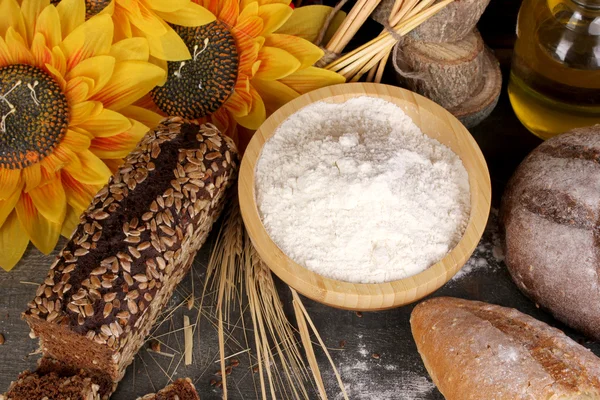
[255,96,470,283]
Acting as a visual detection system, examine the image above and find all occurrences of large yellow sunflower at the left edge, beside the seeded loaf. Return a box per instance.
[0,0,165,270]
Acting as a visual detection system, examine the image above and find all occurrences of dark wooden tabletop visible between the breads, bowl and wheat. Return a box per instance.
[0,0,600,400]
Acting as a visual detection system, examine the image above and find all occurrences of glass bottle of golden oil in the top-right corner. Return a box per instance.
[508,0,600,139]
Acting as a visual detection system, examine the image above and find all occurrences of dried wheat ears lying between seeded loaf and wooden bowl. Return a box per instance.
[203,193,345,400]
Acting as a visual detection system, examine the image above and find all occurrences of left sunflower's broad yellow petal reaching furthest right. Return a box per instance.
[92,61,165,110]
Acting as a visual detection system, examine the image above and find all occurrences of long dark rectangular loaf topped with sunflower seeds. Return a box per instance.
[24,118,237,382]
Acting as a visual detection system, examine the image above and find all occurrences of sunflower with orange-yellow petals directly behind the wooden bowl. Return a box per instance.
[139,0,344,147]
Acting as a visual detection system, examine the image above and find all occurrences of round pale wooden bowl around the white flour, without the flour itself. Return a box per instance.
[238,83,491,311]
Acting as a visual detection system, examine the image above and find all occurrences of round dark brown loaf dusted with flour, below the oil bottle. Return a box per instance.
[500,125,600,339]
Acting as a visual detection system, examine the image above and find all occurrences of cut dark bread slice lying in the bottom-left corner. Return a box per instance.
[0,371,100,400]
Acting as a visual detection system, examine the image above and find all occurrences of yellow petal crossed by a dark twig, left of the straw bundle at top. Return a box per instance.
[277,5,346,45]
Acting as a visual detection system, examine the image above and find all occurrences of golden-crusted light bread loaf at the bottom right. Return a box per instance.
[410,297,600,400]
